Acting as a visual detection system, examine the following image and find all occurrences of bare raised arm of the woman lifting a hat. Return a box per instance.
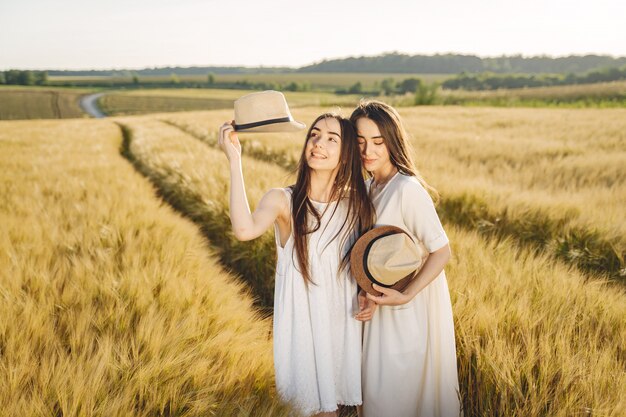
[219,122,290,240]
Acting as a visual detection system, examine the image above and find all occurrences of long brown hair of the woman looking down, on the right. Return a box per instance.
[350,100,439,203]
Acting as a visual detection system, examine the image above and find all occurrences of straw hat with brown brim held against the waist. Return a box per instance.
[350,226,429,296]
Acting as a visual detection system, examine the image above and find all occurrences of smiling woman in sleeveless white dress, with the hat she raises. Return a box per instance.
[219,92,374,416]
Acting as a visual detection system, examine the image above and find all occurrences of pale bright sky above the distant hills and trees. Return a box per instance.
[0,0,626,70]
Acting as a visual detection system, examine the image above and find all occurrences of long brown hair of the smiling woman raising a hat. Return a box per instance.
[291,113,374,285]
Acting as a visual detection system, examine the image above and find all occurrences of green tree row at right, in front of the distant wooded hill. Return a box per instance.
[441,67,626,91]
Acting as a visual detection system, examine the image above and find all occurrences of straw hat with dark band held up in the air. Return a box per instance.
[233,90,306,133]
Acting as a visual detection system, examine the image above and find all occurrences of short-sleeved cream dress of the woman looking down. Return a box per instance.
[363,173,460,417]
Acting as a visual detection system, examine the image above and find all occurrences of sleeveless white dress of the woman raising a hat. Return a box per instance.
[274,190,362,415]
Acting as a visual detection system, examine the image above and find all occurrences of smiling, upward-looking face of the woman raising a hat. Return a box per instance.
[305,117,341,171]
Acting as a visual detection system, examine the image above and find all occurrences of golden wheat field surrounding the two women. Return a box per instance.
[0,107,626,417]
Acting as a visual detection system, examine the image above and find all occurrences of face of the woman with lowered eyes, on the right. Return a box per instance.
[356,117,393,174]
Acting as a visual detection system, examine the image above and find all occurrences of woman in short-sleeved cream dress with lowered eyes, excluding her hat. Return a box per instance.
[350,101,460,417]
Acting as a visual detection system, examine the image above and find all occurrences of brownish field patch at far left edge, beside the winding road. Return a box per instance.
[0,86,91,120]
